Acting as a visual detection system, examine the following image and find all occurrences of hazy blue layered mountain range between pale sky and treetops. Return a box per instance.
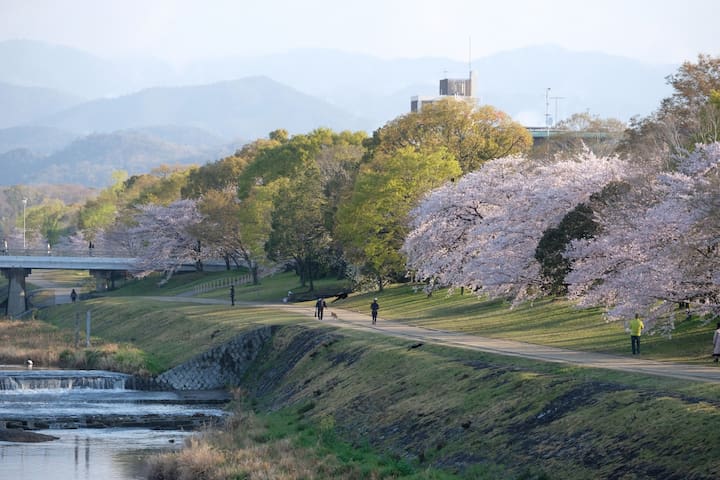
[0,40,677,186]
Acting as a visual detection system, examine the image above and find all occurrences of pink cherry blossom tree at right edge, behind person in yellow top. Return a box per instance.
[566,143,720,333]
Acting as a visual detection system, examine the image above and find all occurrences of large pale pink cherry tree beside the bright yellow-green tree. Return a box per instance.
[403,151,627,301]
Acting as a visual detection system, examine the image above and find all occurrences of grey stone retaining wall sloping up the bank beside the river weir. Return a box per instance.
[156,327,277,390]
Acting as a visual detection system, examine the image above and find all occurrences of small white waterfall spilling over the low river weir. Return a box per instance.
[0,370,130,391]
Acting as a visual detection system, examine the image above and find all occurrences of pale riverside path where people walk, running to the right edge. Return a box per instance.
[141,297,720,383]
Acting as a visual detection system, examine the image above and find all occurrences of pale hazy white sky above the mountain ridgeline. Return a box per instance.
[0,0,720,68]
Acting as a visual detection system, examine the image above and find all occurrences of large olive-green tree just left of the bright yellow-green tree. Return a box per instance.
[238,129,366,288]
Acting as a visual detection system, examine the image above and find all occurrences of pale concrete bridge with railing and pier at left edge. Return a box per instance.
[0,250,137,317]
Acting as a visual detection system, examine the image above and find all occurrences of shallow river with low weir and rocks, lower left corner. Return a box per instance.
[0,370,227,480]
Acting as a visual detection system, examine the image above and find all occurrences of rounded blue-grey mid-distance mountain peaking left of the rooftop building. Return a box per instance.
[34,77,369,140]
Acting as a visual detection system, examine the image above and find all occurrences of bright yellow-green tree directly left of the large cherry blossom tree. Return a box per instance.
[336,147,462,290]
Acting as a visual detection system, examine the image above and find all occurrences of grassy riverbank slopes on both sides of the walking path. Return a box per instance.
[10,275,720,479]
